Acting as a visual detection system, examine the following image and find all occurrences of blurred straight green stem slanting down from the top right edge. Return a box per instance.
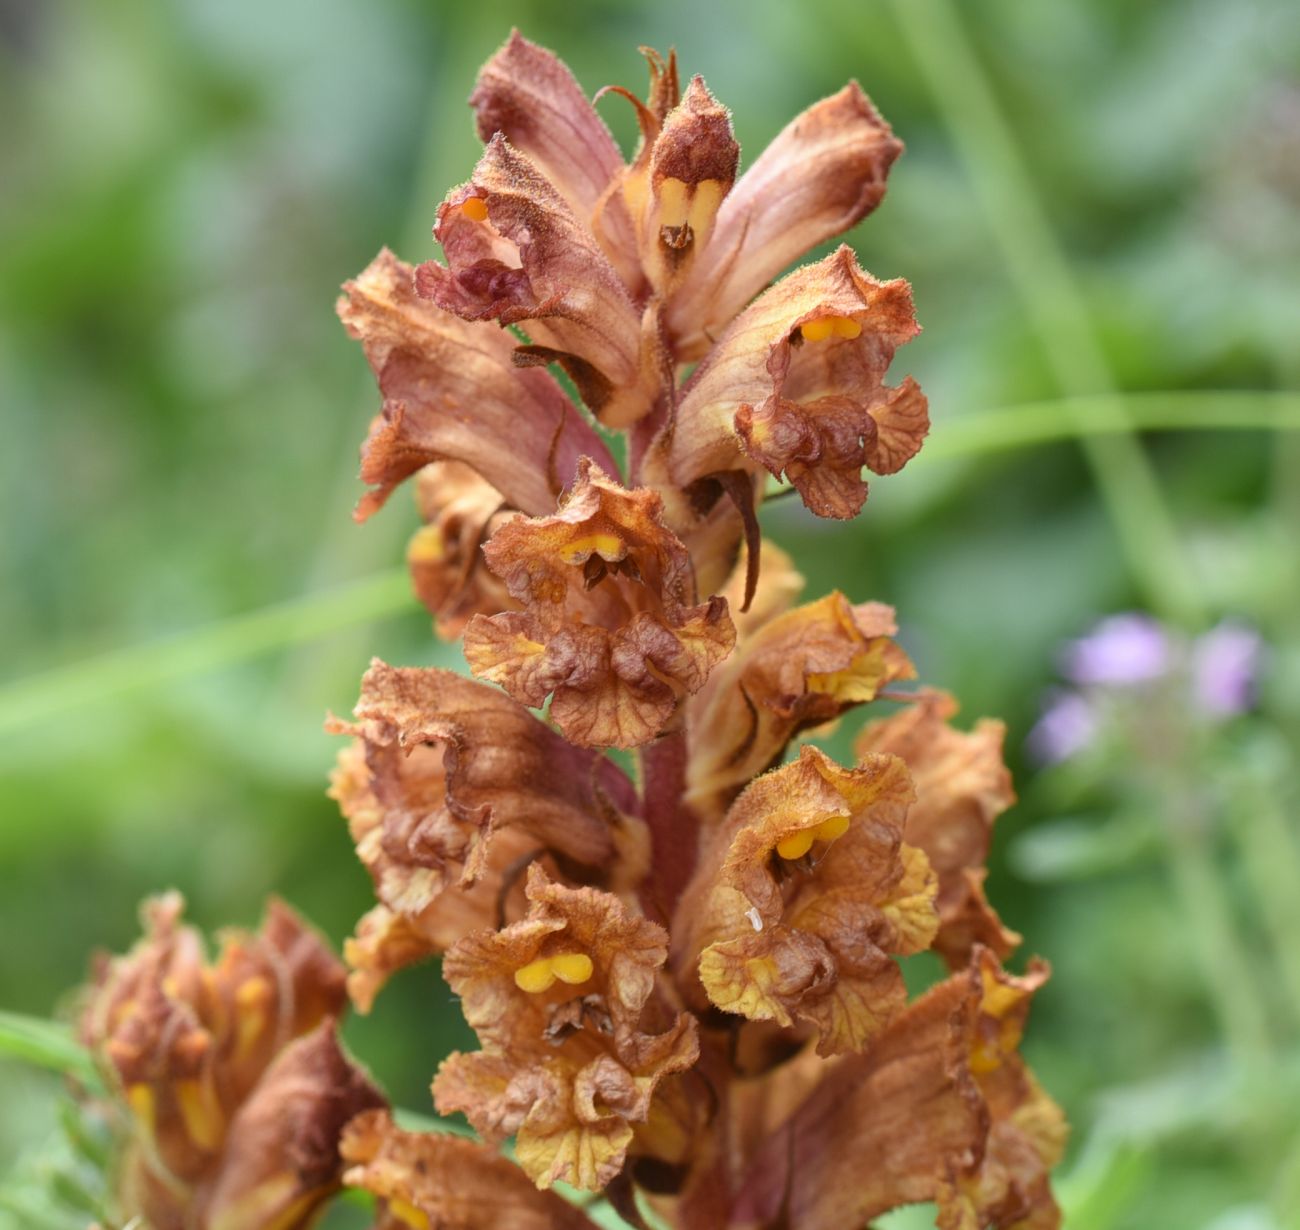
[891,0,1204,627]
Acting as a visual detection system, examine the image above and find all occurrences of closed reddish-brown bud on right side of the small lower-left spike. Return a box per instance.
[196,1021,386,1230]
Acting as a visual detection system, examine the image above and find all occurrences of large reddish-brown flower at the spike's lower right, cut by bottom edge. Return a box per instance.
[731,949,1065,1230]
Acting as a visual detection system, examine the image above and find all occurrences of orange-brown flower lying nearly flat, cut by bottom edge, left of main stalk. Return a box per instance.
[339,1110,594,1230]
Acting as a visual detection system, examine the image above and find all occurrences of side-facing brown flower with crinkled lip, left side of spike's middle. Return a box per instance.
[330,659,641,1012]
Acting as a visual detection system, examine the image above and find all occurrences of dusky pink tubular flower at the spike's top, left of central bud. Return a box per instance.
[469,30,623,218]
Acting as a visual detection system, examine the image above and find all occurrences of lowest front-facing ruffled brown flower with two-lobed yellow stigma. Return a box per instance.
[433,866,698,1188]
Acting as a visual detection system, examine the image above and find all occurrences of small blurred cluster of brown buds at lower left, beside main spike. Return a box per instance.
[81,893,384,1230]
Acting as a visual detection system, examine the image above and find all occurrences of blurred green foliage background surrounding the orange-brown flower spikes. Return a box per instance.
[0,0,1300,1230]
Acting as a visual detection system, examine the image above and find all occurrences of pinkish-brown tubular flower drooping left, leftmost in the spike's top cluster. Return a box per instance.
[338,248,614,520]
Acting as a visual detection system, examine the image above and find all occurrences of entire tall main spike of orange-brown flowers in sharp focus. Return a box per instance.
[330,34,1065,1230]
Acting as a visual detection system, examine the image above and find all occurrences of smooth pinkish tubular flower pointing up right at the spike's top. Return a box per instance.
[667,82,902,360]
